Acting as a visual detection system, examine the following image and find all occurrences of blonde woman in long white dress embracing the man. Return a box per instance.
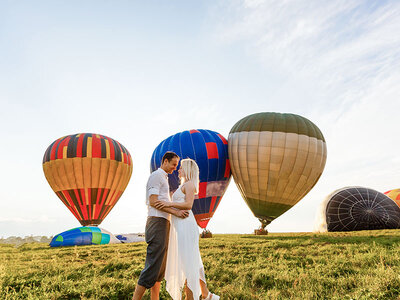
[156,159,219,300]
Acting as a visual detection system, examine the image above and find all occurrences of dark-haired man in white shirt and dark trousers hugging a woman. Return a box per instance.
[132,152,189,300]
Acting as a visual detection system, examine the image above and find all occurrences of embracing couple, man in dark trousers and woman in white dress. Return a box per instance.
[133,152,219,300]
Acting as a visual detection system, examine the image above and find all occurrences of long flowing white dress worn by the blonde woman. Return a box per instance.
[165,187,206,300]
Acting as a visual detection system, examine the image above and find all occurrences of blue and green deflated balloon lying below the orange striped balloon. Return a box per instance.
[50,226,121,247]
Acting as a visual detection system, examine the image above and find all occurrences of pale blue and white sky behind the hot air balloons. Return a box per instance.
[0,0,400,237]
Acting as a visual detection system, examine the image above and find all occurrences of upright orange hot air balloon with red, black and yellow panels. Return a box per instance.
[43,133,132,226]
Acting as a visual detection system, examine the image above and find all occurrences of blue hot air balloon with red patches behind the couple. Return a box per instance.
[150,129,231,229]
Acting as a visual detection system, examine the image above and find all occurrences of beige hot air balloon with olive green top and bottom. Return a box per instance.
[228,112,327,232]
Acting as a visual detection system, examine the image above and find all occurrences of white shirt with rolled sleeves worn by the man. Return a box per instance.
[146,168,171,220]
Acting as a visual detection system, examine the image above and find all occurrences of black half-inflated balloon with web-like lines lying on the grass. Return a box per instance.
[326,187,400,231]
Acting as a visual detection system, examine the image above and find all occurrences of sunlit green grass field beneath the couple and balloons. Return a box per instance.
[0,230,400,299]
